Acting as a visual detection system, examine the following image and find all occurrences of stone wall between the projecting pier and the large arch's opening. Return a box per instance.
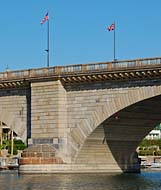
[66,81,161,162]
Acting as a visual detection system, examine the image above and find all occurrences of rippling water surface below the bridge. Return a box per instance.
[0,171,161,190]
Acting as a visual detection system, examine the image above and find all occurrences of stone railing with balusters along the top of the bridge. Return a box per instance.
[0,57,161,80]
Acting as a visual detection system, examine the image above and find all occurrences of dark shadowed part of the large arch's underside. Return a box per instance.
[102,95,161,172]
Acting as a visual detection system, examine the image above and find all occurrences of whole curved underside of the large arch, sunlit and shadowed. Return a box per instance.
[74,95,161,172]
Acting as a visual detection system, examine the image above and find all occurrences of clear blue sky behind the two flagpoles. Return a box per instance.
[0,0,161,71]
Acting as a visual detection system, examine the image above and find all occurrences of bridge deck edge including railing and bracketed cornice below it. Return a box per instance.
[0,57,161,88]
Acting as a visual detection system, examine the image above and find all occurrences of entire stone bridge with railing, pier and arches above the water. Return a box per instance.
[0,57,161,173]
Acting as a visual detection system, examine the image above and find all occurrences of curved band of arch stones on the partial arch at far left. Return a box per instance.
[0,109,27,142]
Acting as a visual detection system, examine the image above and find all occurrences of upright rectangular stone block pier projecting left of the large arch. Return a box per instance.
[29,81,67,159]
